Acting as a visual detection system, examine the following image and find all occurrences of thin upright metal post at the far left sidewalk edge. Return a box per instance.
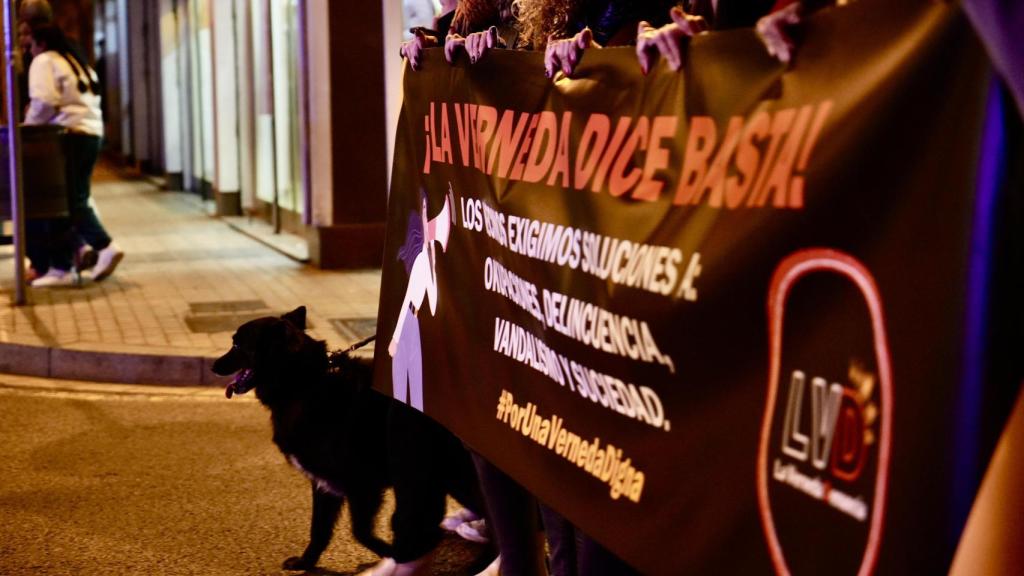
[3,0,28,306]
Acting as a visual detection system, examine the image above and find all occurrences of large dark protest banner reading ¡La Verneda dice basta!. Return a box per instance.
[375,0,1024,574]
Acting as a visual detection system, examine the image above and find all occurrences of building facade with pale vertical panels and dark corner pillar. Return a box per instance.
[91,0,407,268]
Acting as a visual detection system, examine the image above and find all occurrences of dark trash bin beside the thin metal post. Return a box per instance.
[0,125,68,220]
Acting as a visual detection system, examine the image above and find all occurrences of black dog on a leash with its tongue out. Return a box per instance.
[213,306,482,570]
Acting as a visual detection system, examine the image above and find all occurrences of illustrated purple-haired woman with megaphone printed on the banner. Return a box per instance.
[387,187,453,412]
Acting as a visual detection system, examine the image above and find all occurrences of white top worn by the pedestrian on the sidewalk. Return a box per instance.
[25,50,103,136]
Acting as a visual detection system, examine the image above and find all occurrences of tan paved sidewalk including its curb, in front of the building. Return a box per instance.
[0,165,380,385]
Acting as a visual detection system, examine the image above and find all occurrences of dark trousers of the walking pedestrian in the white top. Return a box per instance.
[26,132,111,274]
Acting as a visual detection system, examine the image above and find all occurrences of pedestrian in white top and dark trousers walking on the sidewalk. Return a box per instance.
[25,26,124,287]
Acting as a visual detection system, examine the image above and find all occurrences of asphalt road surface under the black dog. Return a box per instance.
[0,375,487,576]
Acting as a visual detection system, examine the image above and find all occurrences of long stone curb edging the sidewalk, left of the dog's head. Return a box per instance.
[0,343,229,386]
